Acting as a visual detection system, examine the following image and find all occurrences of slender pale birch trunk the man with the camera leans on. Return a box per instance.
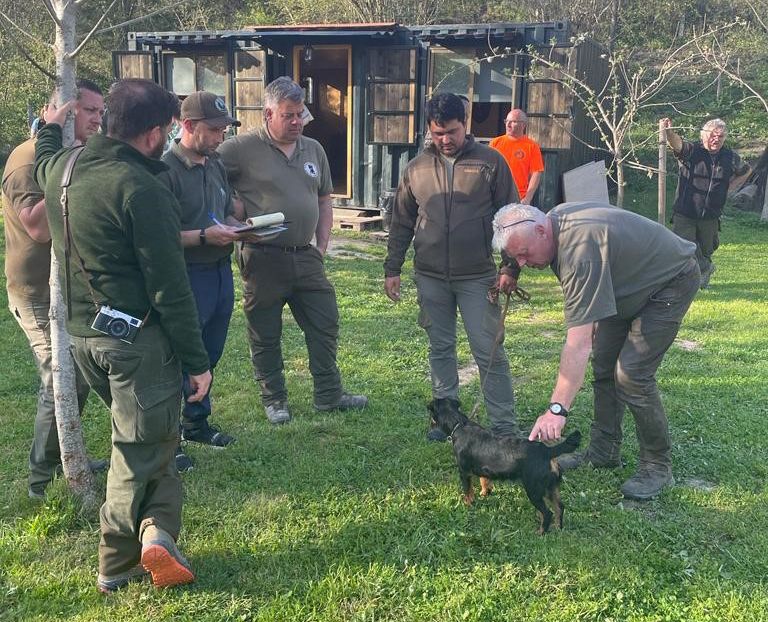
[49,0,100,508]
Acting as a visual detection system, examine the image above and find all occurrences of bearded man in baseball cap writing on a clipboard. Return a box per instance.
[159,91,243,471]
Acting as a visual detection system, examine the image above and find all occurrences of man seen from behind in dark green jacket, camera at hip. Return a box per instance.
[35,79,211,592]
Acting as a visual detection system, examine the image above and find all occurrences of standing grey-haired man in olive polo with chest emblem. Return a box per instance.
[219,77,368,425]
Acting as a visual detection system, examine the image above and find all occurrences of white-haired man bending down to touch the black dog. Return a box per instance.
[493,202,700,499]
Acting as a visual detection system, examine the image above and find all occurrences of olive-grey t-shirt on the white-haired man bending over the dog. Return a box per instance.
[547,201,696,328]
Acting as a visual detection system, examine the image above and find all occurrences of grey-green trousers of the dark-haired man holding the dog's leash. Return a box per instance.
[414,274,518,434]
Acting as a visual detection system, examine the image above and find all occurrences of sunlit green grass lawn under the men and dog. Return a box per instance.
[0,200,768,622]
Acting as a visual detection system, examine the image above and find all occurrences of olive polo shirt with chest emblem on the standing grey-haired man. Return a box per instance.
[219,129,333,246]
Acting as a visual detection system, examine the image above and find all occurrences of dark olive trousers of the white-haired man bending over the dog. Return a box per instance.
[589,258,701,467]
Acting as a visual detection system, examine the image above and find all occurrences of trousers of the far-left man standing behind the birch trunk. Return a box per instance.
[8,292,88,493]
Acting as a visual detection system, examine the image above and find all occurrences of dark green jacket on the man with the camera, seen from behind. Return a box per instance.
[35,124,208,374]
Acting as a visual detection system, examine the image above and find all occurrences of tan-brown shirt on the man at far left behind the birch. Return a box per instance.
[3,139,51,302]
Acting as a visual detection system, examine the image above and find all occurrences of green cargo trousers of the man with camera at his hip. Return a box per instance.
[72,325,182,575]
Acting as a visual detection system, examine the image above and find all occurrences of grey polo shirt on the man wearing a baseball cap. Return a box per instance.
[158,141,234,263]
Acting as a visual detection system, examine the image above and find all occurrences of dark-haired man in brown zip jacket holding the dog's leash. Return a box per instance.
[384,93,520,440]
